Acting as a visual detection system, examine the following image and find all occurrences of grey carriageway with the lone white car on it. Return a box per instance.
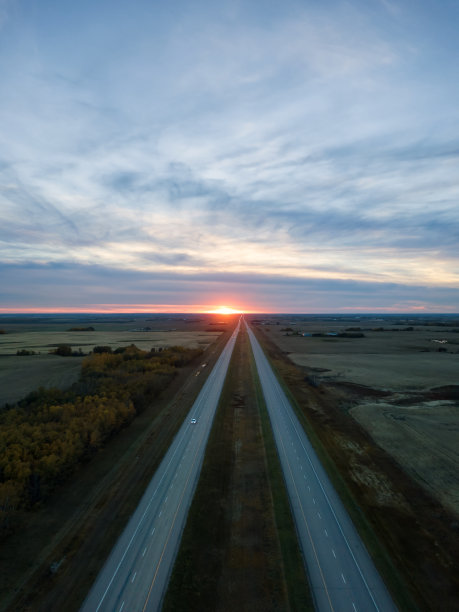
[81,322,240,612]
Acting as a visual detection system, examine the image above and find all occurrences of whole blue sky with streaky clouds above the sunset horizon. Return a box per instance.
[0,0,459,313]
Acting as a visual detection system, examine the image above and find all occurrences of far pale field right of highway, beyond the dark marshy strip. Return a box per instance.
[258,319,459,391]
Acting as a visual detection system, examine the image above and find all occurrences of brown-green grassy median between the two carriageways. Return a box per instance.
[163,322,312,612]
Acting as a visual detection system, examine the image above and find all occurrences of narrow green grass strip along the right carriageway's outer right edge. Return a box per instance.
[252,326,419,611]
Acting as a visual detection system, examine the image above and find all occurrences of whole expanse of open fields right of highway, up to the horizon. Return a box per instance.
[255,316,459,514]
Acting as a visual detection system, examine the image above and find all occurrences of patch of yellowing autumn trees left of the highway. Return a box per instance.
[0,345,202,535]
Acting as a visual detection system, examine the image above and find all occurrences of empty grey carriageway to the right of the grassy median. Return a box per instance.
[247,326,397,612]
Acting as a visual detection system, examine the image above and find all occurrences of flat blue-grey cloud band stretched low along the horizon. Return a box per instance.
[0,264,459,312]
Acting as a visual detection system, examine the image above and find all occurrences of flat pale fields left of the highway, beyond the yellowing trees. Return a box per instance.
[0,315,226,406]
